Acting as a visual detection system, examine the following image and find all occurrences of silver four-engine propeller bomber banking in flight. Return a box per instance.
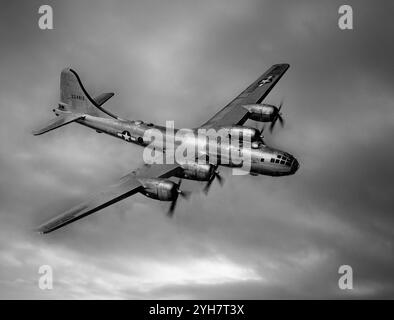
[33,64,299,233]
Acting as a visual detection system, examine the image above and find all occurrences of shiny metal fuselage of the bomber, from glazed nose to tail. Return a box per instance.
[77,115,299,176]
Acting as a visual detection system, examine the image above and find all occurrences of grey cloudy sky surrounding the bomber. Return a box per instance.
[0,0,394,299]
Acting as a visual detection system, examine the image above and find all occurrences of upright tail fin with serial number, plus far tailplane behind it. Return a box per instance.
[60,68,119,119]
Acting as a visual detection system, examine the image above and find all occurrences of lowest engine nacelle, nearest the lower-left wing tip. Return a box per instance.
[139,178,178,201]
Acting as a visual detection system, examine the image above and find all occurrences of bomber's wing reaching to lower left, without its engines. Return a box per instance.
[37,164,179,233]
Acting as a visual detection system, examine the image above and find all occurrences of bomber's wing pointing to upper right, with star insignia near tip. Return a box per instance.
[201,63,290,129]
